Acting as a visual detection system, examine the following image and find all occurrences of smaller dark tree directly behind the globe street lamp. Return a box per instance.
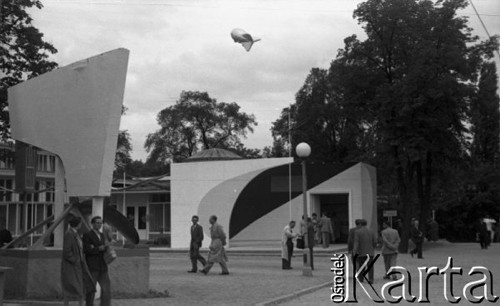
[271,64,373,162]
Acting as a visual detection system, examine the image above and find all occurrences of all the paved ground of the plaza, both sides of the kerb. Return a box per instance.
[6,242,500,306]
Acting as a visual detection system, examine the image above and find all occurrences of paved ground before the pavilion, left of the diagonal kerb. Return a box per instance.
[117,247,342,306]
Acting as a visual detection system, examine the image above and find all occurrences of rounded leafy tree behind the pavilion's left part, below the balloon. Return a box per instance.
[145,91,257,162]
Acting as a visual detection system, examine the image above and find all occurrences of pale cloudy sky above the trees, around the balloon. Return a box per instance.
[31,0,500,160]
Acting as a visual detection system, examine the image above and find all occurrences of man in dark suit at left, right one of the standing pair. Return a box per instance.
[83,216,111,306]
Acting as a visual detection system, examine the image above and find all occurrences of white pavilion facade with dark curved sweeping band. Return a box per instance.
[171,158,377,248]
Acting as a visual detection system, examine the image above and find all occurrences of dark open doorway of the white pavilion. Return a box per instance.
[319,193,349,243]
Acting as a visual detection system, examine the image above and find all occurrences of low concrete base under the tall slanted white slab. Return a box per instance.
[0,248,149,299]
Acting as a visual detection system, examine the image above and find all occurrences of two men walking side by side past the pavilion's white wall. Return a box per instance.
[188,215,229,275]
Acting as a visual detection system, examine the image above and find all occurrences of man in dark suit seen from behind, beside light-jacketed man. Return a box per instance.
[353,219,378,284]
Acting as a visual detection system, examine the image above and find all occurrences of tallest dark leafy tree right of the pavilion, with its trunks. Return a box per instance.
[336,0,498,250]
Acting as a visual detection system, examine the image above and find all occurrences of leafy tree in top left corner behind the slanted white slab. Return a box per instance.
[0,0,57,141]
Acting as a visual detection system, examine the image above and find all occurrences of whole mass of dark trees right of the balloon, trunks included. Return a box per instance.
[273,0,498,249]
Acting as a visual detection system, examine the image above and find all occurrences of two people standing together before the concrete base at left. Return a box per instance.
[61,216,111,306]
